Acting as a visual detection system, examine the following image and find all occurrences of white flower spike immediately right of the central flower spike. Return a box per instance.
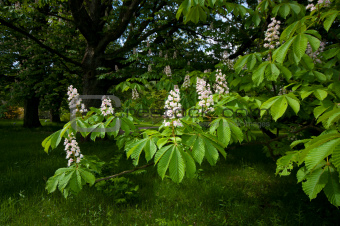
[196,78,214,113]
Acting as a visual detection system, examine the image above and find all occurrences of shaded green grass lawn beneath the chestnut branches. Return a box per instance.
[0,121,340,225]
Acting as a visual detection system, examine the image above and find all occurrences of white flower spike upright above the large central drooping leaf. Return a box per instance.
[163,88,183,127]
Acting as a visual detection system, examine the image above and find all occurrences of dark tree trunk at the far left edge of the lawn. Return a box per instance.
[24,97,41,128]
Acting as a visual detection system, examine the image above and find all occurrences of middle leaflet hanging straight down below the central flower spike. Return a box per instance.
[169,146,185,183]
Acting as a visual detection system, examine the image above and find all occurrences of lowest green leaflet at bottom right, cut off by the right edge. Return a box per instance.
[323,166,340,207]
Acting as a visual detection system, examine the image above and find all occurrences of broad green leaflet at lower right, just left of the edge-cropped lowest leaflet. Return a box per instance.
[302,168,328,199]
